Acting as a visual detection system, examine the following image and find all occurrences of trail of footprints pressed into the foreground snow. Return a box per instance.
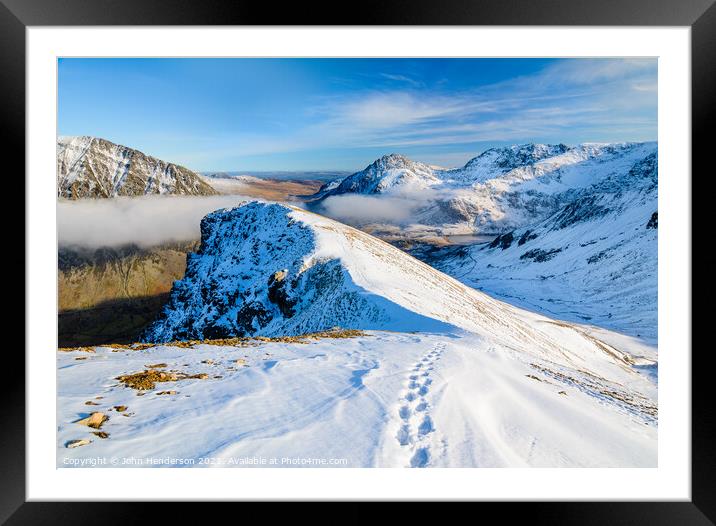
[395,343,445,468]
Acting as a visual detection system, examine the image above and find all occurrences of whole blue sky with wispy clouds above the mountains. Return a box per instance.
[58,58,657,171]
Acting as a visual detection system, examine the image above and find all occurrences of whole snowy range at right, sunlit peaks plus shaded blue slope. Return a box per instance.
[312,143,658,342]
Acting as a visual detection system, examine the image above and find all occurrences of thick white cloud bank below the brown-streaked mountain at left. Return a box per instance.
[57,195,257,248]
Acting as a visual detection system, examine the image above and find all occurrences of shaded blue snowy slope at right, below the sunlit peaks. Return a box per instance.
[415,149,658,343]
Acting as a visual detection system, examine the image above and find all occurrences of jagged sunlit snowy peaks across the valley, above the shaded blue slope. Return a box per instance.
[313,143,656,234]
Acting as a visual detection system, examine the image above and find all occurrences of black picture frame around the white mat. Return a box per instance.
[0,0,716,525]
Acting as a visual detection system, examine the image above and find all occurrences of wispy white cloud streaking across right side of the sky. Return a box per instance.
[159,59,657,171]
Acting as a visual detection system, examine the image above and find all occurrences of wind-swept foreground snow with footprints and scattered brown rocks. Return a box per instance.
[57,331,657,467]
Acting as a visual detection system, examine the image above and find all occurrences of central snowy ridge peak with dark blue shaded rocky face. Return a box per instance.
[143,202,584,342]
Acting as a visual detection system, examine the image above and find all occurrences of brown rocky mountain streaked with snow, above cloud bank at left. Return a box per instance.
[57,136,217,199]
